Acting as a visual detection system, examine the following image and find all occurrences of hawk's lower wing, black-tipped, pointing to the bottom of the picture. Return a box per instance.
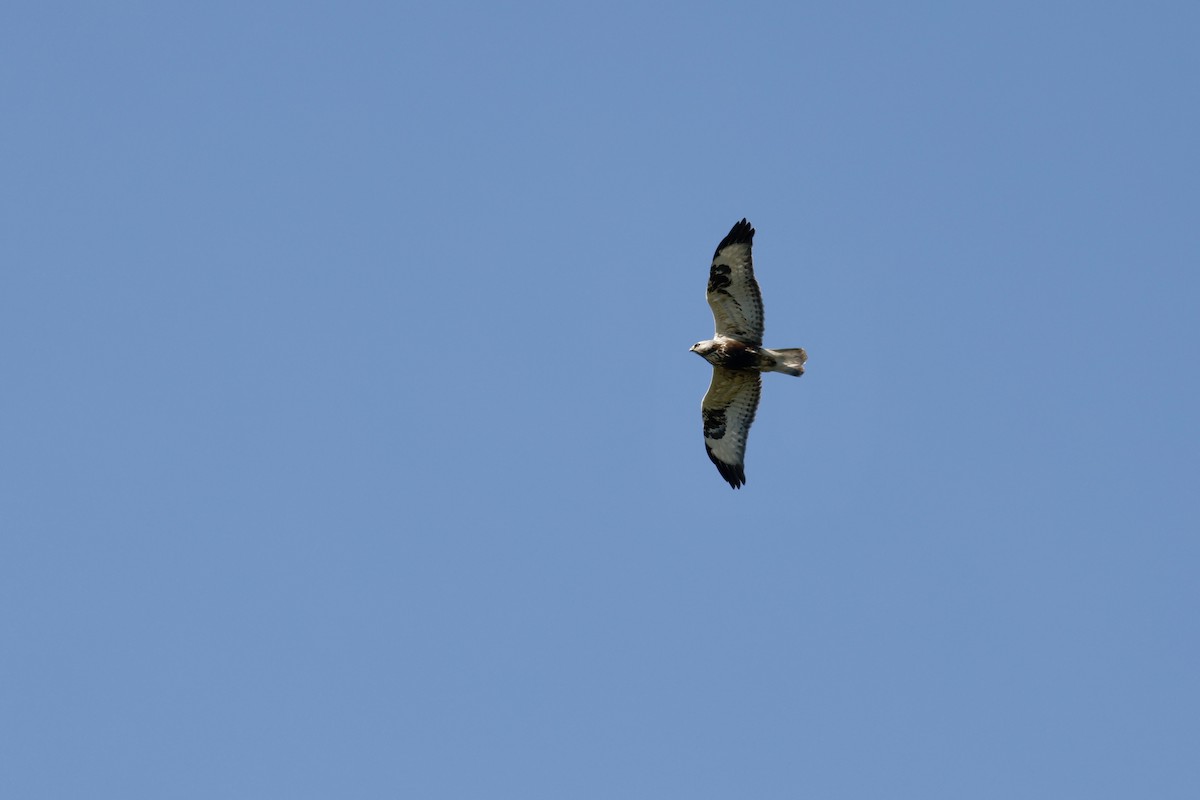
[701,367,762,488]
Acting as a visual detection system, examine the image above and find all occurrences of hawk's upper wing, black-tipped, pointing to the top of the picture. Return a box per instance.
[708,219,762,344]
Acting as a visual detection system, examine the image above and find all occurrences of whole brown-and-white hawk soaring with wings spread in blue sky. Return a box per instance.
[691,219,809,489]
